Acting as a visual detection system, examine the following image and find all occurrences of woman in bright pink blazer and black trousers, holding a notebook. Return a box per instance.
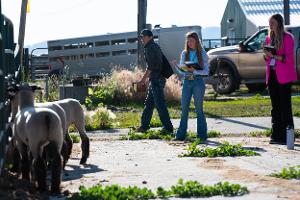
[264,14,297,144]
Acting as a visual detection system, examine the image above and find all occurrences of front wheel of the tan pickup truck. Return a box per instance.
[213,67,236,94]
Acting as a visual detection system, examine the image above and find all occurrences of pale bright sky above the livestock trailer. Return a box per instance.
[1,0,228,45]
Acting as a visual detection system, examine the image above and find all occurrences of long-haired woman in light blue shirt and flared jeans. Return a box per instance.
[175,32,208,141]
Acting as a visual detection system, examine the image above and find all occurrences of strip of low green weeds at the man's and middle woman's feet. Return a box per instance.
[120,129,221,141]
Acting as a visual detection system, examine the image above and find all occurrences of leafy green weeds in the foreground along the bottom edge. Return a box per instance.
[69,179,249,200]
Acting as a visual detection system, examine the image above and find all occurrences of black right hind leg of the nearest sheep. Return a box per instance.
[51,152,62,194]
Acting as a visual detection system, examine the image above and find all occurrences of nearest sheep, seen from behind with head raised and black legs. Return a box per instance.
[13,85,64,193]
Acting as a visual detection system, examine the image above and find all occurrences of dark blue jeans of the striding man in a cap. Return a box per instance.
[141,79,173,132]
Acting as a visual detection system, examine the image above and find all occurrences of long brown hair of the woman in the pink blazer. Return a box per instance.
[269,14,285,49]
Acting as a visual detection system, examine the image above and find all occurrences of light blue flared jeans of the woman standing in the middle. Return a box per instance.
[176,78,207,140]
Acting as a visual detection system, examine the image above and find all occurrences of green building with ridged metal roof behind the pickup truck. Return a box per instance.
[221,0,300,43]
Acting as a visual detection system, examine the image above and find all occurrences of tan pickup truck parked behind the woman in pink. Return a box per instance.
[207,26,300,94]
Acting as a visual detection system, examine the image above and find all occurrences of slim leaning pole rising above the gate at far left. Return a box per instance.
[18,0,28,79]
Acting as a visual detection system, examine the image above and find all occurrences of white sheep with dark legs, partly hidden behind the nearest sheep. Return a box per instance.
[11,93,90,166]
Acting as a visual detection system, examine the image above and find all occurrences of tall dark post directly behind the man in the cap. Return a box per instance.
[137,0,147,68]
